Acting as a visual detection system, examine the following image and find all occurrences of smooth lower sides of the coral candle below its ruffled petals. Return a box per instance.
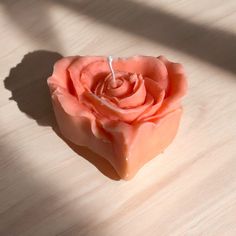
[53,92,182,180]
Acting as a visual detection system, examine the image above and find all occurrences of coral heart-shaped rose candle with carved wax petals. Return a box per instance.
[48,56,187,179]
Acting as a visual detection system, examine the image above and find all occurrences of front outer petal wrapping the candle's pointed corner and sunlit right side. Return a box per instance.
[103,109,182,179]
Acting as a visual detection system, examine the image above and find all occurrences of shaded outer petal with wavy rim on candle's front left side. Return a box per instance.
[52,86,114,153]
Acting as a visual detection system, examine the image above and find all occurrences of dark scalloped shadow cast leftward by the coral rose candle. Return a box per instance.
[4,50,119,180]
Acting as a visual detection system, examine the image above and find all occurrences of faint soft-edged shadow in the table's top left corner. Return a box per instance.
[0,0,63,51]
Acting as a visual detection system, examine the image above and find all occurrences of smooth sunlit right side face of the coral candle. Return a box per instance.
[126,109,182,179]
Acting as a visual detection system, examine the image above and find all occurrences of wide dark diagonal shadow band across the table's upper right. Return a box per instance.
[57,0,236,74]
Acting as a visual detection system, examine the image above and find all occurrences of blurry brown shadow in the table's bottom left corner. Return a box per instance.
[0,142,101,236]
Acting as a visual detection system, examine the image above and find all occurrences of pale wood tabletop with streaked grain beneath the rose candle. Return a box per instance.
[0,0,236,236]
